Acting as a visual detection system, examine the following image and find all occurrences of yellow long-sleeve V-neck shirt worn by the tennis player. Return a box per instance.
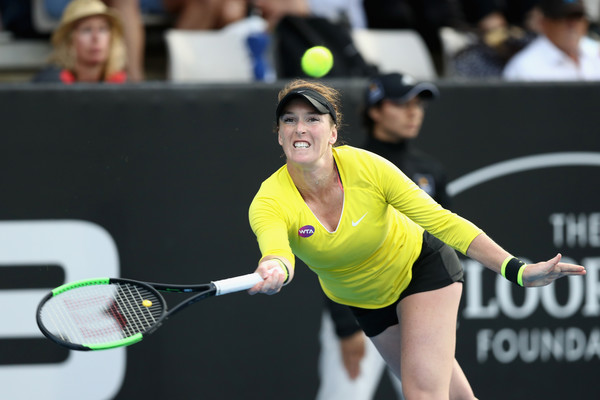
[249,146,481,308]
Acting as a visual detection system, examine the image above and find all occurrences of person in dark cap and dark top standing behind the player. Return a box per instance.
[316,73,464,400]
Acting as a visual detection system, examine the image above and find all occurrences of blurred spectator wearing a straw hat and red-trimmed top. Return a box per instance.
[34,0,127,84]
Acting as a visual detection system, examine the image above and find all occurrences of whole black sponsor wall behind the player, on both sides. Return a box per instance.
[0,80,600,399]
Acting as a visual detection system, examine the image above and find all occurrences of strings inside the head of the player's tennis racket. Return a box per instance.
[41,283,164,345]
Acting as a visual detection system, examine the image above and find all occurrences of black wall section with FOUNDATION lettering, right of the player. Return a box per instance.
[420,84,600,399]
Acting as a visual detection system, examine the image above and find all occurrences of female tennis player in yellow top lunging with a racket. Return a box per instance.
[249,80,585,399]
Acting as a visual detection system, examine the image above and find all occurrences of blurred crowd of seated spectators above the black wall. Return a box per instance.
[0,0,600,82]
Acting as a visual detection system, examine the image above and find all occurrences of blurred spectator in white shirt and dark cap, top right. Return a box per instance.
[503,0,600,81]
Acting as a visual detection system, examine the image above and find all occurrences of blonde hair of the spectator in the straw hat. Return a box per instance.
[50,15,127,80]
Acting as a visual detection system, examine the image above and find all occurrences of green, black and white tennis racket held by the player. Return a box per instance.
[36,273,263,351]
